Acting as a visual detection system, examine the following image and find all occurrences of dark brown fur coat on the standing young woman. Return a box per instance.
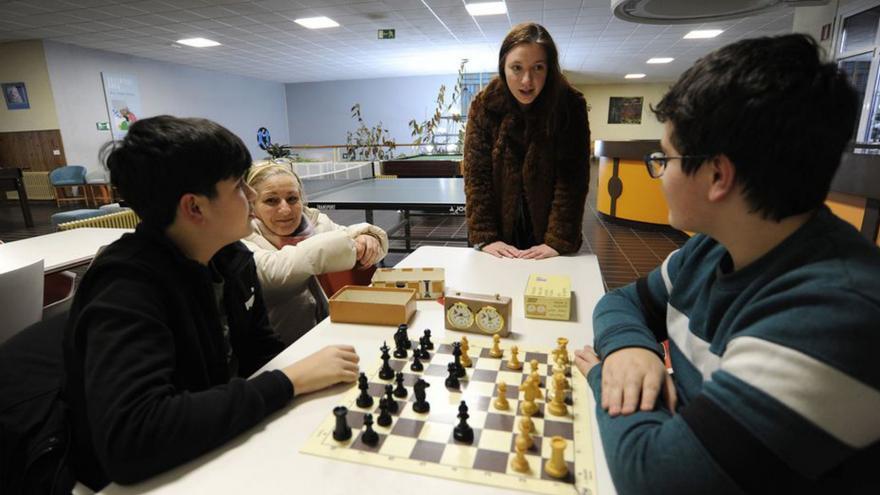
[462,78,590,254]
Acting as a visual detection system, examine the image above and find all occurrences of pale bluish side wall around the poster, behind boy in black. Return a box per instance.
[44,41,288,175]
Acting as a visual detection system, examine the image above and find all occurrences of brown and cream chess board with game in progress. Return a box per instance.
[301,338,596,495]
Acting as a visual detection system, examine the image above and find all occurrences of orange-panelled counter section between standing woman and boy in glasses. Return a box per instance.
[596,140,669,225]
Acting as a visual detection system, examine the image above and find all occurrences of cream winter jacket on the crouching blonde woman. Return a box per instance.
[242,207,388,344]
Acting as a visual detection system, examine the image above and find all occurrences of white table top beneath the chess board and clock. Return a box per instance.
[103,246,614,495]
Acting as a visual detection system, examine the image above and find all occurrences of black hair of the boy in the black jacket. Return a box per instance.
[101,115,251,229]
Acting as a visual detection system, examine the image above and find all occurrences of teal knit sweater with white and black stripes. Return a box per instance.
[588,208,880,494]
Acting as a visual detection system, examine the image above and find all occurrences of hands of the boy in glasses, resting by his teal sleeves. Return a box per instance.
[574,346,676,416]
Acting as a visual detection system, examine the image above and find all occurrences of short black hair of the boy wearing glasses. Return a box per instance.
[651,34,858,221]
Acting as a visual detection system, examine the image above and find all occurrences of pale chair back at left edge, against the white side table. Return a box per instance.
[0,259,43,344]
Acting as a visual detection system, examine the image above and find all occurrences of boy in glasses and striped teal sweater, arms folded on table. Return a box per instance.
[575,34,880,494]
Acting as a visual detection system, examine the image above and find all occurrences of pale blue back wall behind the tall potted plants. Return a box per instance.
[286,74,457,153]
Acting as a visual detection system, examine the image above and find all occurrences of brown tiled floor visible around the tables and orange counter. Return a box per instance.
[0,166,687,289]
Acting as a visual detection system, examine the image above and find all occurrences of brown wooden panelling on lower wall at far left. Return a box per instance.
[0,129,67,172]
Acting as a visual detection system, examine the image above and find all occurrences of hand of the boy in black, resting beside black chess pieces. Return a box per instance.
[281,345,360,395]
